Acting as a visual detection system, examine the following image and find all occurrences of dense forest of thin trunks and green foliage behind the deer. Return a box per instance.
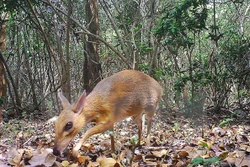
[0,0,250,118]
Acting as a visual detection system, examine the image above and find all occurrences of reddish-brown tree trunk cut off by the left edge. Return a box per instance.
[0,14,7,122]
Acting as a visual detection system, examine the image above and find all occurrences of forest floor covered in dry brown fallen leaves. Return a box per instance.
[0,106,250,167]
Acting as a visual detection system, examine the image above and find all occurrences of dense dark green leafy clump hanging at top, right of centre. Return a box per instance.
[154,0,208,48]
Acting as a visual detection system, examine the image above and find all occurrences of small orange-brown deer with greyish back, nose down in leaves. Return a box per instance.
[54,70,162,156]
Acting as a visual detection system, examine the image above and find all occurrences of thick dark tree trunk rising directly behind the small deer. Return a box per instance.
[83,0,102,92]
